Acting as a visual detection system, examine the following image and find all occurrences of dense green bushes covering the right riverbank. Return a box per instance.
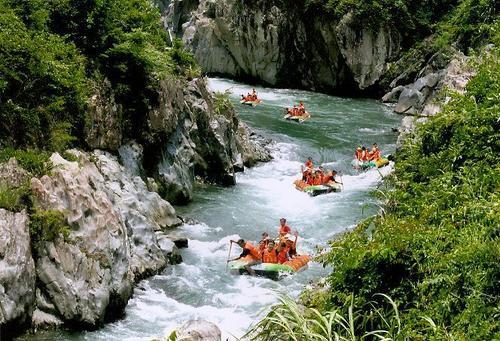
[252,42,500,340]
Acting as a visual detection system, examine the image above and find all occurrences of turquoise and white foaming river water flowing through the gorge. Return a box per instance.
[25,78,400,340]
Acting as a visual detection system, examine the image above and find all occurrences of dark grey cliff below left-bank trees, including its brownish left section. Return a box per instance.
[86,78,271,203]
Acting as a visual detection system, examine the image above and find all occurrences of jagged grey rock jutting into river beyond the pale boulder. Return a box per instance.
[152,79,271,203]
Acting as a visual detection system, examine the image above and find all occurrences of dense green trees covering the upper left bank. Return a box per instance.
[0,0,196,150]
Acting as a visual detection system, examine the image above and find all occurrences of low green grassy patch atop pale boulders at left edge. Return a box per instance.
[0,148,52,177]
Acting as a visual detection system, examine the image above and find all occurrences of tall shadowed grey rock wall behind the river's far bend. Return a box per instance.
[162,0,401,92]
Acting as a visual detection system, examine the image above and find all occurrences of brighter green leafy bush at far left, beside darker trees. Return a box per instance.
[0,0,86,148]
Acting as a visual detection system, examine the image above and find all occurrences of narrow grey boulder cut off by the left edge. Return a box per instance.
[0,209,36,338]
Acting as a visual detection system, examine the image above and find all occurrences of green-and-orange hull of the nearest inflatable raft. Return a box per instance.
[228,255,311,280]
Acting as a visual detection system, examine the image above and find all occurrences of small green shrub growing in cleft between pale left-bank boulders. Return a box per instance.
[29,210,71,246]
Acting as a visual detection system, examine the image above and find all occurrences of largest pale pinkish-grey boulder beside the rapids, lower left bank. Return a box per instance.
[27,151,180,328]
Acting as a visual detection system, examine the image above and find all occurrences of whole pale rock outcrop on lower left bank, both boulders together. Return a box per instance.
[0,151,181,335]
